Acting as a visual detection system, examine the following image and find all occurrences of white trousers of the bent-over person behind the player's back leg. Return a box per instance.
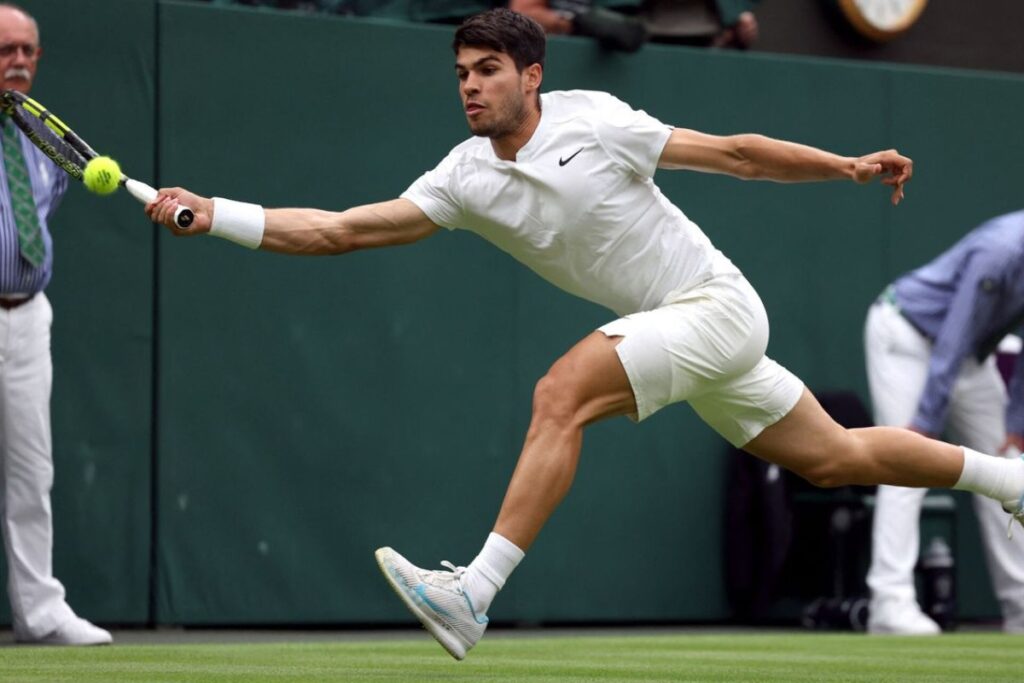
[864,302,1024,630]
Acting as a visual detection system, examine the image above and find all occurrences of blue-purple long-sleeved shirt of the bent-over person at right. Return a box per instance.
[894,211,1024,434]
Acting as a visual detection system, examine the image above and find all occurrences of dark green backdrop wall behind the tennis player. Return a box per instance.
[8,0,1024,625]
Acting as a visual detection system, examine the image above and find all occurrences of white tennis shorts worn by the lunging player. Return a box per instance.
[599,274,804,447]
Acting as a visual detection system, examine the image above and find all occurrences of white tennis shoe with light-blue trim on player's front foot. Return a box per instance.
[374,548,487,659]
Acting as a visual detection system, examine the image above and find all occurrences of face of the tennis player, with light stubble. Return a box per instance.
[455,47,528,138]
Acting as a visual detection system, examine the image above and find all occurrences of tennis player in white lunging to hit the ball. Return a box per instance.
[145,9,1024,659]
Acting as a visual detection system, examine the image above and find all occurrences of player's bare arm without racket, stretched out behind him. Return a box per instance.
[658,128,913,204]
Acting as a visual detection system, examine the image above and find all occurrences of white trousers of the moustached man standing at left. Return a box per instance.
[0,294,74,638]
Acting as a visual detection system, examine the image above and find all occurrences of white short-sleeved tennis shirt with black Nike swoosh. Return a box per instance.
[401,90,739,315]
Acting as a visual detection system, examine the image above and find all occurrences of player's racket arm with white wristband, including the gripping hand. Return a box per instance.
[145,187,439,255]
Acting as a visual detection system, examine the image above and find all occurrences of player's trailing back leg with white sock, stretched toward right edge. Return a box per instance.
[743,389,1024,516]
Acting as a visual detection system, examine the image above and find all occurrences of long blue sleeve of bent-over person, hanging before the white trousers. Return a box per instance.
[911,256,1001,435]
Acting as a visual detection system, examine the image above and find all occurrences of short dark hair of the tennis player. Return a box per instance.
[452,7,547,73]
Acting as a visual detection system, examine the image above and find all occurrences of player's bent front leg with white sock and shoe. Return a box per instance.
[377,332,636,659]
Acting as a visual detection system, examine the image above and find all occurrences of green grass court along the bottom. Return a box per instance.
[0,632,1024,683]
